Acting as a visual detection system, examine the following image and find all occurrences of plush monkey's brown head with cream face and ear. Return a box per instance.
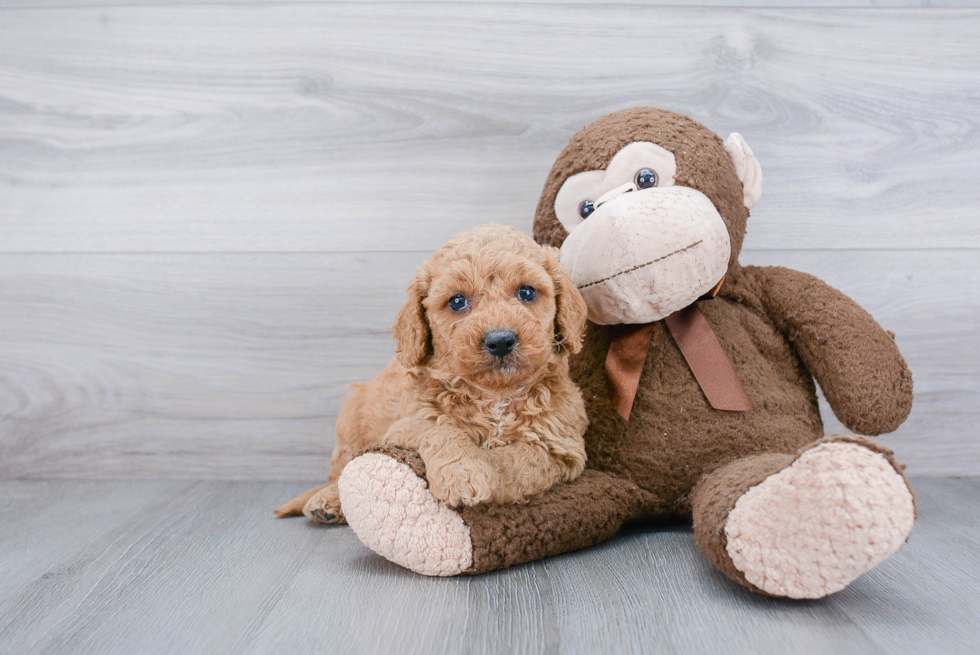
[534,108,762,325]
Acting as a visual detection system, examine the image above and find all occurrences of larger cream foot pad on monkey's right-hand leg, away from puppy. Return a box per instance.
[725,443,915,598]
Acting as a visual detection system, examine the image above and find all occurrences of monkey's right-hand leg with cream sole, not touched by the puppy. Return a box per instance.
[691,435,915,598]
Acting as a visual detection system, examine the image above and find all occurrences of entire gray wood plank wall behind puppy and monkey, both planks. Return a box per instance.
[0,2,980,479]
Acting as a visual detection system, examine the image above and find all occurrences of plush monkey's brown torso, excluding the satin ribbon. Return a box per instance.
[572,298,823,516]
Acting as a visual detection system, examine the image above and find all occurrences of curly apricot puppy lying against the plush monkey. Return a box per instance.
[276,223,588,523]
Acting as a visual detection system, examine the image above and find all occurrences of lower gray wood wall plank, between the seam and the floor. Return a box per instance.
[0,251,980,479]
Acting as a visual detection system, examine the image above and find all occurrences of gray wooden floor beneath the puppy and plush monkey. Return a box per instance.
[0,478,980,655]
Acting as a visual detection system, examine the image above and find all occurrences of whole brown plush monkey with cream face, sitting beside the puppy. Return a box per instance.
[341,108,915,598]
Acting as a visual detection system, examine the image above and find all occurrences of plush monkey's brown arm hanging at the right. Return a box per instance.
[745,266,912,435]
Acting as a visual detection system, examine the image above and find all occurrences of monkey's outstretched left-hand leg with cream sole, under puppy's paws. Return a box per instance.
[340,447,648,576]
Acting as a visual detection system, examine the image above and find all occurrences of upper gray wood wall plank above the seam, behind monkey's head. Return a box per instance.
[0,3,980,252]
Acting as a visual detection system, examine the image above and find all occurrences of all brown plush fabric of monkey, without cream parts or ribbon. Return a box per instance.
[464,108,912,583]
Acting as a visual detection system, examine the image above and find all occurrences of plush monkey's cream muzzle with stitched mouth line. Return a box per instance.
[561,183,731,325]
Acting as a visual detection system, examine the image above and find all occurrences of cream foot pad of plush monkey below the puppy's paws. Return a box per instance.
[339,453,473,576]
